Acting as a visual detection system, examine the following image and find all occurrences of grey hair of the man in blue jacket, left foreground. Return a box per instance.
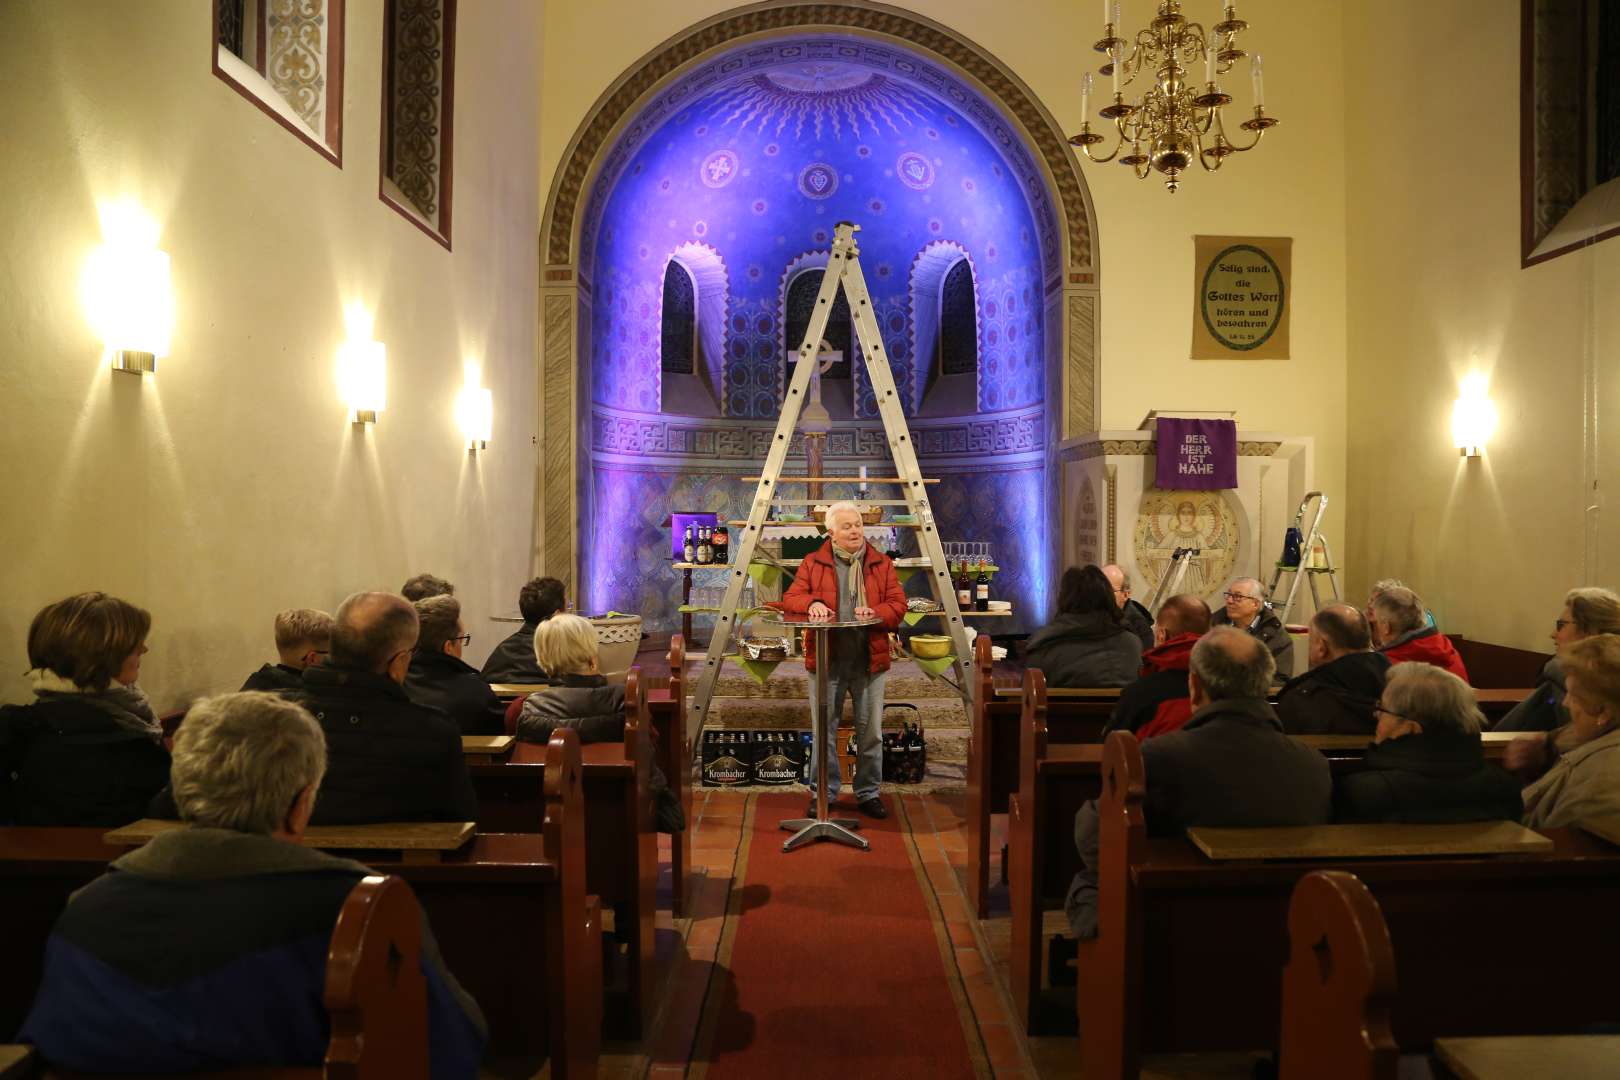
[168,690,326,836]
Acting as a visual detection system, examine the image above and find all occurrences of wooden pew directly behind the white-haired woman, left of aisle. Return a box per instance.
[467,667,658,1038]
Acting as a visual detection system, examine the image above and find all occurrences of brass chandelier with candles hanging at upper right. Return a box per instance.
[1069,0,1277,194]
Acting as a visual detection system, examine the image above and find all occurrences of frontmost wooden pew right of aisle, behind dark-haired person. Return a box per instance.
[967,633,1119,918]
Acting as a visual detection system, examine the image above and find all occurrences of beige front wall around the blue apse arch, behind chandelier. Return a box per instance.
[539,0,1353,592]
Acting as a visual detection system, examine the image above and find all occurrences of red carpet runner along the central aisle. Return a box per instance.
[693,792,988,1080]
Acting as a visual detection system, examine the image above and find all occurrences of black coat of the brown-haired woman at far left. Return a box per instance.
[0,695,168,827]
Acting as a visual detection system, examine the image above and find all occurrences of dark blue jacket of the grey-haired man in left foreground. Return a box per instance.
[18,827,484,1078]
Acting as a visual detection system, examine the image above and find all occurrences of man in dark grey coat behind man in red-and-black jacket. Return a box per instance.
[1063,627,1333,938]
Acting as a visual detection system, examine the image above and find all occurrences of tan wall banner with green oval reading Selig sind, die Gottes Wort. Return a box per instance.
[1192,236,1294,359]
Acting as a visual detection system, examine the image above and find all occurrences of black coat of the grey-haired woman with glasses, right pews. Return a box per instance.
[1333,733,1524,824]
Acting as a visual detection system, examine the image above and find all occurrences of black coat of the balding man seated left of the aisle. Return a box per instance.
[298,667,478,826]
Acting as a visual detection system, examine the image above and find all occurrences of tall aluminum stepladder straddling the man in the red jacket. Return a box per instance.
[687,222,972,751]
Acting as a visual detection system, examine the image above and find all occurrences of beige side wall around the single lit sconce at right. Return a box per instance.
[1345,0,1620,651]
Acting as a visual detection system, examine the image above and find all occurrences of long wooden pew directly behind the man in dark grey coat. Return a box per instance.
[1076,732,1620,1080]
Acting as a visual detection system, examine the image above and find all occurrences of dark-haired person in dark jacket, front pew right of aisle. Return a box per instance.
[1024,567,1142,687]
